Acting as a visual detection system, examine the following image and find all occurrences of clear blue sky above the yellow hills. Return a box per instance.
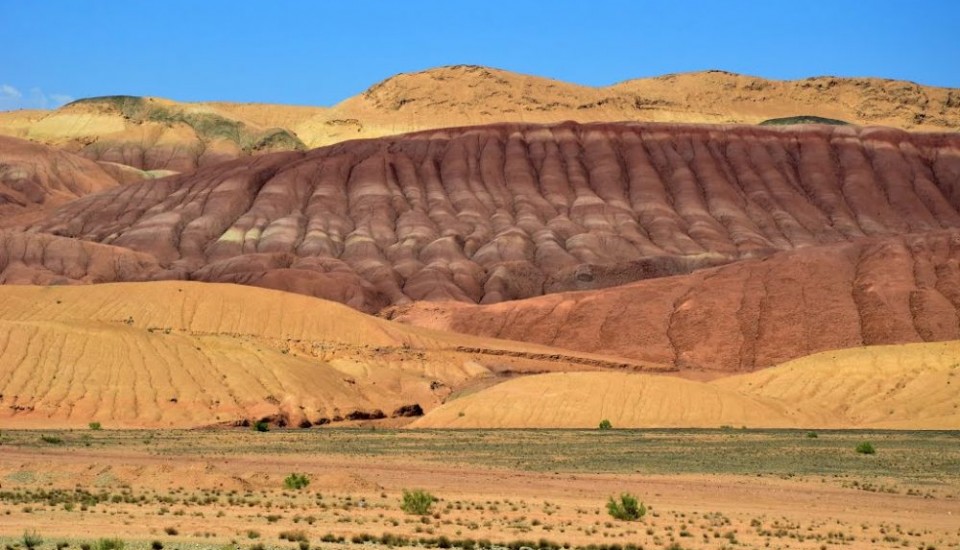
[0,0,960,110]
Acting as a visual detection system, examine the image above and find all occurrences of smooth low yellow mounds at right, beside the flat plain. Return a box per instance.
[413,342,960,429]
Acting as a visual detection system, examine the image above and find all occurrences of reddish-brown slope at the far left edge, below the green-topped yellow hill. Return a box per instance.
[0,136,124,227]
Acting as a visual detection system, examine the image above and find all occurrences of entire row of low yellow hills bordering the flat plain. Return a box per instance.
[0,281,960,429]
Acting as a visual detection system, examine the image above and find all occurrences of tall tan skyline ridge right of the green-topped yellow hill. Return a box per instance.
[320,65,960,145]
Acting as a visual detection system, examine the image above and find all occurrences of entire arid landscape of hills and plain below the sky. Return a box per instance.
[0,66,960,550]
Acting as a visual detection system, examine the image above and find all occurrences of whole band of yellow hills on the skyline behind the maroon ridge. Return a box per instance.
[0,65,960,172]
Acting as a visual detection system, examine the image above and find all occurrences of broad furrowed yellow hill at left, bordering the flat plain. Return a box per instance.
[0,281,656,428]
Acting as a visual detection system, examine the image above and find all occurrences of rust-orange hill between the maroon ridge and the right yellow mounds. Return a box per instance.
[391,231,960,373]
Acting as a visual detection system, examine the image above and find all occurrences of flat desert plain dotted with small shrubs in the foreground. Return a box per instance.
[0,427,960,550]
